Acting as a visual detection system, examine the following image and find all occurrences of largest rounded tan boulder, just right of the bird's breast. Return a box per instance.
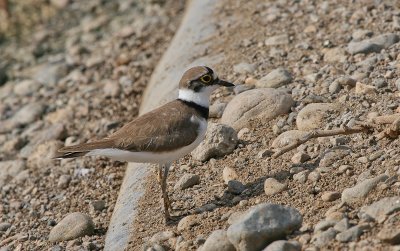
[221,88,293,131]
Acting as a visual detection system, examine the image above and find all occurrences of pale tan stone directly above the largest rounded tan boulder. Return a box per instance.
[255,68,293,88]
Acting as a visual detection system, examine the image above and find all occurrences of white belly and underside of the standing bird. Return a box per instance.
[86,119,207,164]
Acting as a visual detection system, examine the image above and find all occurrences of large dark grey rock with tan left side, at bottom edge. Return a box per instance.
[228,203,303,251]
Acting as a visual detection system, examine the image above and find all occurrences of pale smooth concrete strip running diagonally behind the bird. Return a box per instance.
[104,0,222,251]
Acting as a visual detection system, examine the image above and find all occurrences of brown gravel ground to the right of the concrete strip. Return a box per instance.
[131,1,400,250]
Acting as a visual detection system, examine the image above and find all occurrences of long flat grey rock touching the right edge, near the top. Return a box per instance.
[347,33,400,54]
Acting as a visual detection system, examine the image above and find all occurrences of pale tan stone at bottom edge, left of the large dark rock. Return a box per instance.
[199,230,236,251]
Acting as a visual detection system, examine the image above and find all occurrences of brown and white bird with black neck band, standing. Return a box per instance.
[54,66,234,222]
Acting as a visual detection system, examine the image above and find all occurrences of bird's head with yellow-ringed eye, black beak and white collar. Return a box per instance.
[179,66,234,107]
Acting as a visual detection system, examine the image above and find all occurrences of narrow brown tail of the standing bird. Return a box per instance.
[54,139,113,159]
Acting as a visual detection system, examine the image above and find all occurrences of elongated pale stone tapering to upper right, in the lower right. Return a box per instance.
[342,174,388,205]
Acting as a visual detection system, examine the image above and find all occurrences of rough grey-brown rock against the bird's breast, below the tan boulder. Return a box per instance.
[192,123,238,161]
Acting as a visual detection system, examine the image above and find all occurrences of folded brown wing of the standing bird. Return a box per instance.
[106,101,199,152]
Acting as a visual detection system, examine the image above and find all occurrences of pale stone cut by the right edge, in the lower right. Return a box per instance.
[360,196,400,222]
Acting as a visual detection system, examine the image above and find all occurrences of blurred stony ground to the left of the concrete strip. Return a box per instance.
[0,0,183,250]
